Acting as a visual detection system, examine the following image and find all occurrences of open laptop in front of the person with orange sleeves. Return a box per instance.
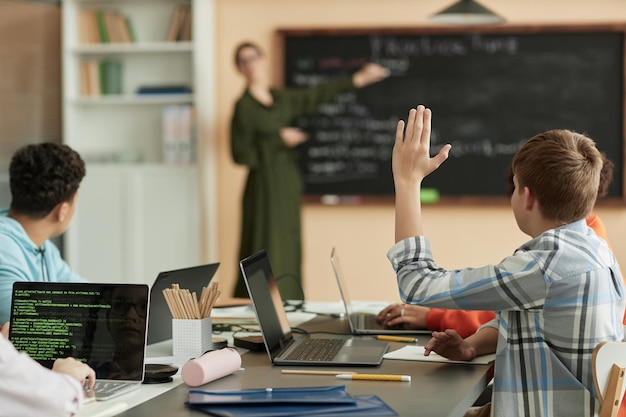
[330,248,432,335]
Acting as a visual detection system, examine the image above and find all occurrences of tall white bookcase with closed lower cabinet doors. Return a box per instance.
[62,0,215,283]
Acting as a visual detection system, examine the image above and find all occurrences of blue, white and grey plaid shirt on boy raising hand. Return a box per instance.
[387,220,626,417]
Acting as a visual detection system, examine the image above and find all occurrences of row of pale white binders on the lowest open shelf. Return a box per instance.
[162,104,197,165]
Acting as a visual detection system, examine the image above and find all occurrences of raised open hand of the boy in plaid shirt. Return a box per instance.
[392,105,451,187]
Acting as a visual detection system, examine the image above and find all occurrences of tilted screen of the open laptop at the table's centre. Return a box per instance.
[240,251,292,357]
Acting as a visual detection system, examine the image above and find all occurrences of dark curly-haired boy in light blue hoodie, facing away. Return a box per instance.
[0,143,85,324]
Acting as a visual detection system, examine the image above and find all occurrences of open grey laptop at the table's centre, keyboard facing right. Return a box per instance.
[239,251,389,366]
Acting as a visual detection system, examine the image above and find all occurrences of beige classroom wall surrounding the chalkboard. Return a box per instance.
[212,0,626,301]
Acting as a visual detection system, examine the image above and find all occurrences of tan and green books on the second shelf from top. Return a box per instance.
[79,59,122,97]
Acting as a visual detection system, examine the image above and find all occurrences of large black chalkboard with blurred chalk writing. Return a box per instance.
[278,26,625,199]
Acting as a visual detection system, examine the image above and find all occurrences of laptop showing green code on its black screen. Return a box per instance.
[9,282,149,401]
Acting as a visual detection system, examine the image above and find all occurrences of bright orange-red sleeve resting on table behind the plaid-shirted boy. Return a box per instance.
[426,308,496,338]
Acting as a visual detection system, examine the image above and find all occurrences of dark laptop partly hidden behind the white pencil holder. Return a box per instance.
[148,262,220,345]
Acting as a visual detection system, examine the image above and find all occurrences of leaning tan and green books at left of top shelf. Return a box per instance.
[78,9,136,44]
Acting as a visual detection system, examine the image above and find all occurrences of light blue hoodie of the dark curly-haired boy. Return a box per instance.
[0,210,86,326]
